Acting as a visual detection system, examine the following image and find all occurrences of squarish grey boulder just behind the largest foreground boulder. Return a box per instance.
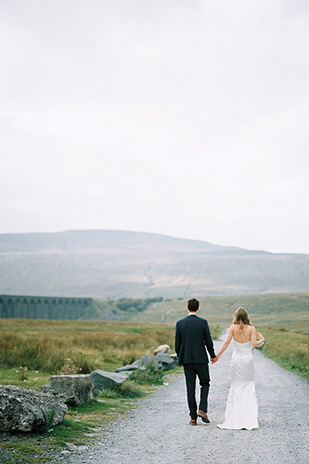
[40,374,94,406]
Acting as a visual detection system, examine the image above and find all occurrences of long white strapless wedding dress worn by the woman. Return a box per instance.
[217,340,259,430]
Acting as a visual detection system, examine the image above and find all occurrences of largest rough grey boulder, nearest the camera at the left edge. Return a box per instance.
[0,385,68,432]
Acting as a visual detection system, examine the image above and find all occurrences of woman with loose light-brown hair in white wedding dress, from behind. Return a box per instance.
[212,308,264,430]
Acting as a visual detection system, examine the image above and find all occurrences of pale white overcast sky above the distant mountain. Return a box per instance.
[0,0,309,253]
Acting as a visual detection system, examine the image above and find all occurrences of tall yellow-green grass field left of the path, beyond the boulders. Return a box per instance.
[0,319,174,374]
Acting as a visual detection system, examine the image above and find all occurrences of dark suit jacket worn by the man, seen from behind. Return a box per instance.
[175,314,216,364]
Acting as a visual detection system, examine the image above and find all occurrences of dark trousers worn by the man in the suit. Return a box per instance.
[183,363,210,419]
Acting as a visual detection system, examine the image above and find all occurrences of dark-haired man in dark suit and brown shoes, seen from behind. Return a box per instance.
[175,298,216,425]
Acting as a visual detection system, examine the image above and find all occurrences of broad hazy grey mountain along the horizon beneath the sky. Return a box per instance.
[0,230,309,298]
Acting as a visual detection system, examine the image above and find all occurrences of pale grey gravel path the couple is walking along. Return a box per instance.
[52,342,309,464]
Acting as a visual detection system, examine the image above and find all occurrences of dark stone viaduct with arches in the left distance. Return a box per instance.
[0,295,92,319]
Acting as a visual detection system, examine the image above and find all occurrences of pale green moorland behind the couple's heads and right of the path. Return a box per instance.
[134,293,309,379]
